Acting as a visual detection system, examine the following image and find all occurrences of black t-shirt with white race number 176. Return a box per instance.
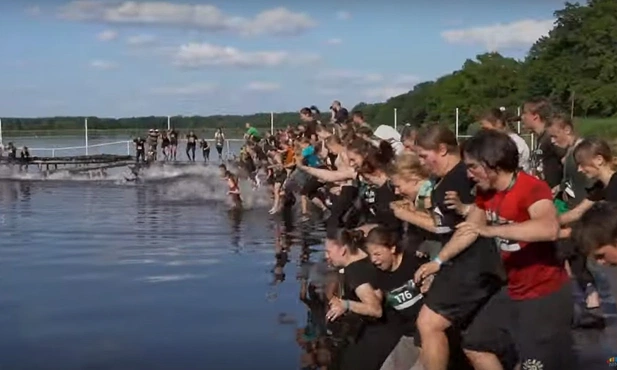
[377,252,428,336]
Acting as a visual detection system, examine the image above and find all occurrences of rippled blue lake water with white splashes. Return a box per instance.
[0,138,617,370]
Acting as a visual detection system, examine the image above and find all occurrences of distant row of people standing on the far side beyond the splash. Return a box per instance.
[133,128,225,163]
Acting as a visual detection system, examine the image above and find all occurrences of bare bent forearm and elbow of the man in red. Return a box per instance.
[485,199,559,243]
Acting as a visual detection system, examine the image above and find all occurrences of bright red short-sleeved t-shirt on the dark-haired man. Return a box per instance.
[476,172,568,300]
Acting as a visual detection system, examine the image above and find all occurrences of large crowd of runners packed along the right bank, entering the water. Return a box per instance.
[220,99,617,370]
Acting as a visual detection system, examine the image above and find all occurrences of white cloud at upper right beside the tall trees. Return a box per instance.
[441,19,554,51]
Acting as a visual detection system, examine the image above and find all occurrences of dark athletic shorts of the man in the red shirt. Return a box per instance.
[510,282,580,370]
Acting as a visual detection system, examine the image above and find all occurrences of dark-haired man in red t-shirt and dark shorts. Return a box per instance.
[457,131,577,369]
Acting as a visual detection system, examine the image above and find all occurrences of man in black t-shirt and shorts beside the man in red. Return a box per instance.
[392,125,510,370]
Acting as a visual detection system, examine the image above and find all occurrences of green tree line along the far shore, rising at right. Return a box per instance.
[2,0,617,131]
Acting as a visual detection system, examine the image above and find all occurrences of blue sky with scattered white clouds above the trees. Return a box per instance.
[0,0,563,117]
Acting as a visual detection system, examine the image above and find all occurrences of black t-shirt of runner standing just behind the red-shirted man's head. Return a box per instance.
[531,131,565,189]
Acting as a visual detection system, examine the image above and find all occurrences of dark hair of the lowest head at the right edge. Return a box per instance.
[571,201,617,255]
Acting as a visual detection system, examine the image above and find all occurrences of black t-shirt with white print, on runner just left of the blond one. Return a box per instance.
[364,181,402,230]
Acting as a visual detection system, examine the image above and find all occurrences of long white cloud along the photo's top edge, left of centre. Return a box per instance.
[59,0,317,36]
